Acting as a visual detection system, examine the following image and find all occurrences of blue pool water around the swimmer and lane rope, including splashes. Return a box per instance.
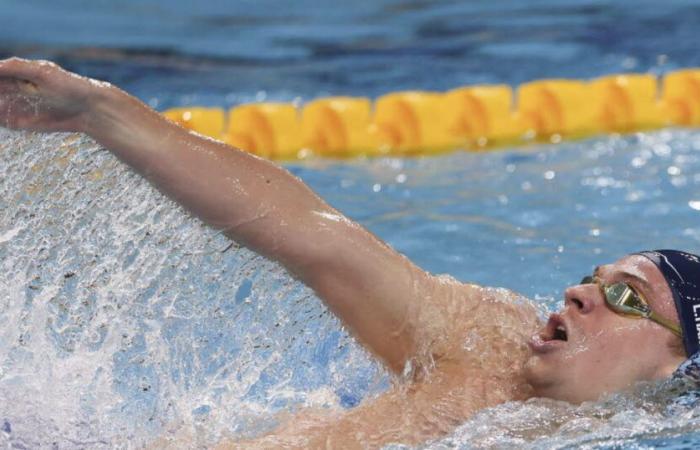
[0,1,700,448]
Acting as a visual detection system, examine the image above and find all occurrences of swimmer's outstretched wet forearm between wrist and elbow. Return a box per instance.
[85,88,334,271]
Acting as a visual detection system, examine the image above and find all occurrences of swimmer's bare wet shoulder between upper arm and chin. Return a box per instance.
[424,275,541,374]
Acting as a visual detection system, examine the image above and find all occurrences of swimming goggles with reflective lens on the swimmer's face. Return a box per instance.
[581,275,683,338]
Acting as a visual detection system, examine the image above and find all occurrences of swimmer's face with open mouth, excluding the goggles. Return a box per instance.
[526,255,684,403]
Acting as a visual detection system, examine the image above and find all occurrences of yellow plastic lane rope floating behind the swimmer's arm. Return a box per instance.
[163,69,700,160]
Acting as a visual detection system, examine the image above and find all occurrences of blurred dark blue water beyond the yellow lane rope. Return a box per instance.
[0,0,700,108]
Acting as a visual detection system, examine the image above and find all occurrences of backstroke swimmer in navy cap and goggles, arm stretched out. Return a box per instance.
[0,58,700,449]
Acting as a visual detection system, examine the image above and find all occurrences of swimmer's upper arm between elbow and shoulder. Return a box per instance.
[300,209,434,372]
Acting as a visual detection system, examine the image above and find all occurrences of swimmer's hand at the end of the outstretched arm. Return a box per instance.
[0,58,108,131]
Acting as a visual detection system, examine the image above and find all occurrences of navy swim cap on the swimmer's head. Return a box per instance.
[636,250,700,356]
